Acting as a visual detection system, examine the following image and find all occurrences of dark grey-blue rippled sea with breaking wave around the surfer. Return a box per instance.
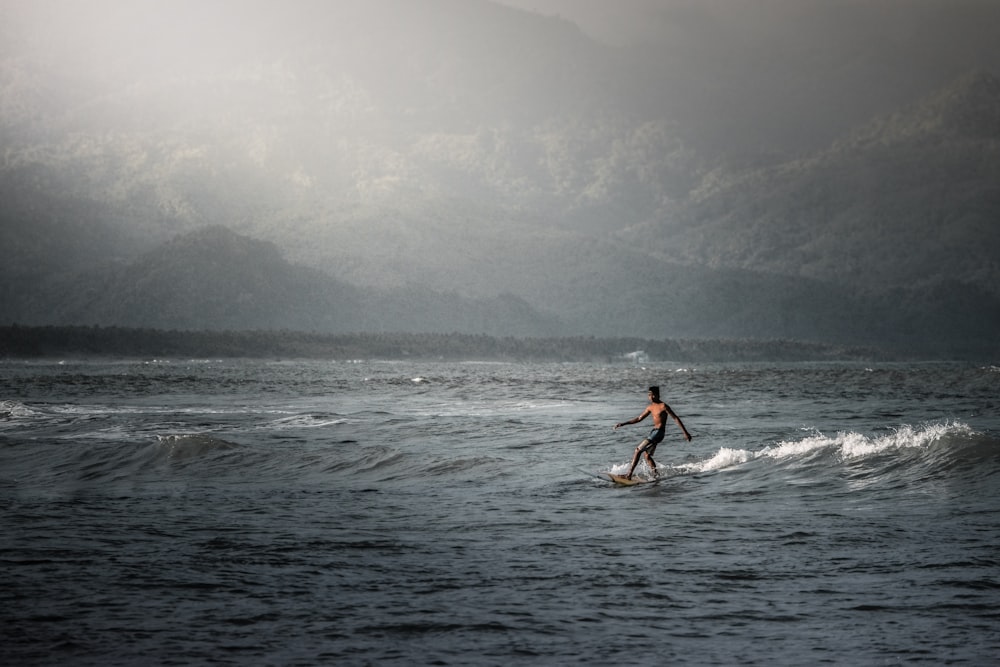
[0,360,1000,665]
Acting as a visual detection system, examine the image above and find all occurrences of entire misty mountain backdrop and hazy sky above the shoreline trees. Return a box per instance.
[0,0,1000,354]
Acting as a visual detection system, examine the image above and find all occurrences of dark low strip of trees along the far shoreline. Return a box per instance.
[0,324,887,364]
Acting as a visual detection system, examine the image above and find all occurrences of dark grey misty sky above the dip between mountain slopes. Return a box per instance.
[502,0,1000,155]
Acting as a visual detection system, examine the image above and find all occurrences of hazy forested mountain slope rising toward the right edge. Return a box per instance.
[622,72,1000,296]
